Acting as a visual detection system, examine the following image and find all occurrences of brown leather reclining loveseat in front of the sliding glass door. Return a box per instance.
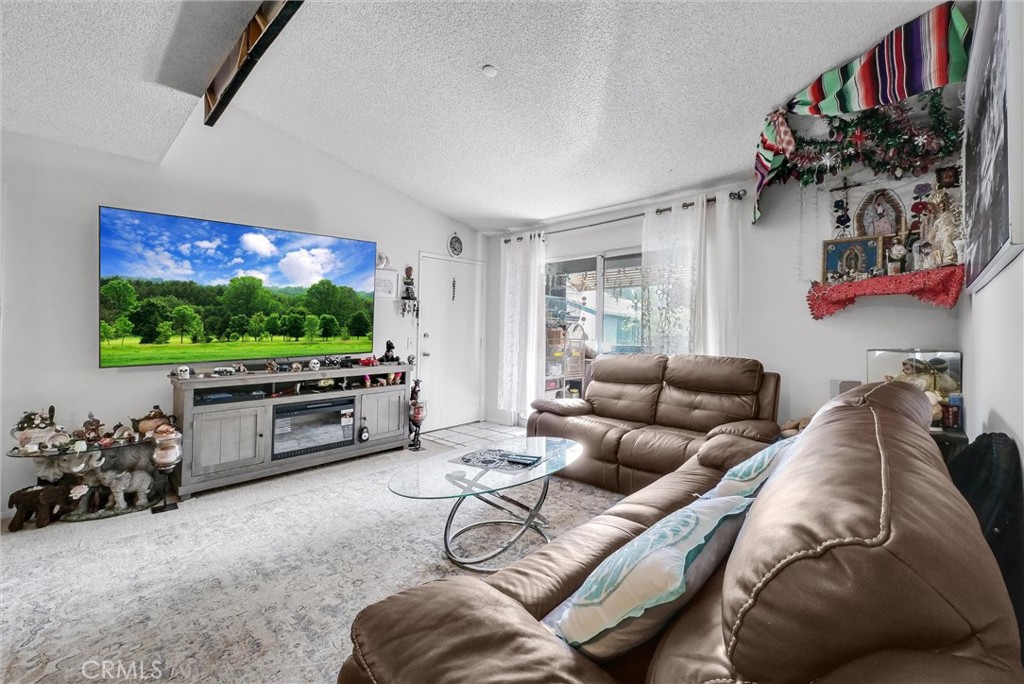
[526,354,779,494]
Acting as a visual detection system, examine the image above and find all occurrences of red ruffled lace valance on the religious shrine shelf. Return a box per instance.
[807,264,964,320]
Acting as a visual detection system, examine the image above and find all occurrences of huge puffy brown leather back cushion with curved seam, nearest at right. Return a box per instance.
[722,383,1020,682]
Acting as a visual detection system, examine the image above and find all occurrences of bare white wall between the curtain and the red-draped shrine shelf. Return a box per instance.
[739,182,959,422]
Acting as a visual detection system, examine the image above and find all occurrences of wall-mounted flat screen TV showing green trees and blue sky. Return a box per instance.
[99,207,377,368]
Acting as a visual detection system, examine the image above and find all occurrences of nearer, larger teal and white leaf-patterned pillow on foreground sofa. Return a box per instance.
[544,497,752,660]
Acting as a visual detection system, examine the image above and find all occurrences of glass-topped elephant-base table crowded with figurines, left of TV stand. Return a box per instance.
[7,407,181,531]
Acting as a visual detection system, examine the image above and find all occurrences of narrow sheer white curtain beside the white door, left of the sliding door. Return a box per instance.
[498,232,545,415]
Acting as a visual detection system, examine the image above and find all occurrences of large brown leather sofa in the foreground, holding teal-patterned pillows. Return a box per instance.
[338,383,1024,684]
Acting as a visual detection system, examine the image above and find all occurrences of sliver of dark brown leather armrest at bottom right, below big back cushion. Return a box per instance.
[814,649,1024,684]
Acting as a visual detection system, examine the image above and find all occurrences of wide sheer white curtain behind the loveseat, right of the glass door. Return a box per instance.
[641,190,741,356]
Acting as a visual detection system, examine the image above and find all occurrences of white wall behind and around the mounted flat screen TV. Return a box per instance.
[0,108,482,498]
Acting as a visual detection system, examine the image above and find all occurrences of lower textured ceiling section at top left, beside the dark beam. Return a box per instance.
[0,1,259,164]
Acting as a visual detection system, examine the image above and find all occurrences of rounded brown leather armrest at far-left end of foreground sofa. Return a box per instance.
[338,576,614,684]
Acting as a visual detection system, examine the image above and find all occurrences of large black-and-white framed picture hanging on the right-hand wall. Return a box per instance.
[963,0,1024,293]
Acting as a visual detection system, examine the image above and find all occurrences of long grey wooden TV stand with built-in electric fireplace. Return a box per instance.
[171,364,416,500]
